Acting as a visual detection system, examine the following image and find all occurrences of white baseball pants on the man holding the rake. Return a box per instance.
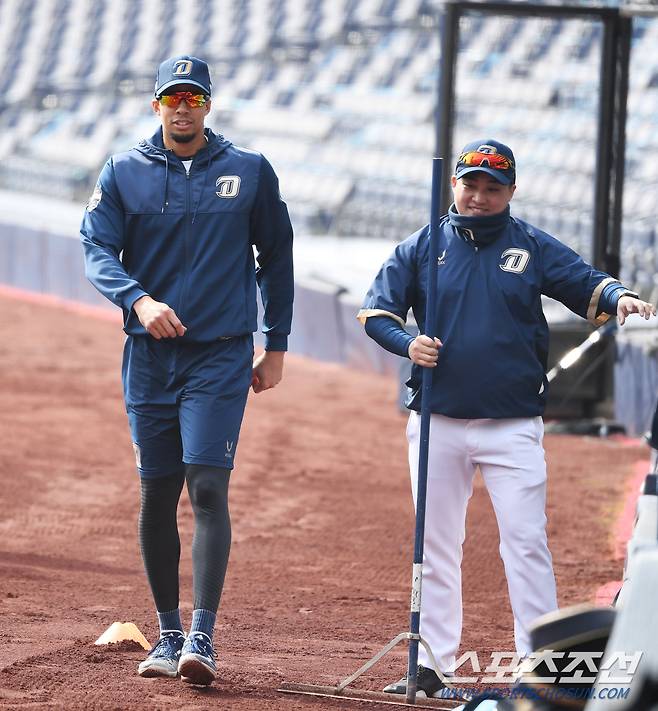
[407,412,557,671]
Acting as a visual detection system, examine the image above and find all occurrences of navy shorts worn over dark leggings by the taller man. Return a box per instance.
[122,334,254,478]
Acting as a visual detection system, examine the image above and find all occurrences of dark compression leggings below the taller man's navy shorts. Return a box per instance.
[139,464,231,612]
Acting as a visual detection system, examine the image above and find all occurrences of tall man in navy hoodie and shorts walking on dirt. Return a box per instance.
[81,56,293,684]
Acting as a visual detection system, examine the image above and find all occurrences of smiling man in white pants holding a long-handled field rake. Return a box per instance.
[359,139,656,696]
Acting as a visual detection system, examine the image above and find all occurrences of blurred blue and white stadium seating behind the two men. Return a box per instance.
[0,0,658,296]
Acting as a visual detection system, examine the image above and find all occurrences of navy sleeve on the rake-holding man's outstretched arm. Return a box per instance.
[541,229,618,325]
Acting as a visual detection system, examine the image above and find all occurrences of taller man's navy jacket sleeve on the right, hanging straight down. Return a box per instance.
[250,156,295,351]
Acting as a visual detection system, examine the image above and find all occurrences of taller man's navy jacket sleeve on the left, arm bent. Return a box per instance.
[80,158,147,311]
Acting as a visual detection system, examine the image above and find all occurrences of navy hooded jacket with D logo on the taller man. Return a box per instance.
[80,129,294,350]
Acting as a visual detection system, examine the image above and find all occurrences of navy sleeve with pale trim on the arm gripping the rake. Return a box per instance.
[357,233,419,328]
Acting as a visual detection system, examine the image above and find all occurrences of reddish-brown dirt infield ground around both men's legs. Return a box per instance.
[0,296,648,710]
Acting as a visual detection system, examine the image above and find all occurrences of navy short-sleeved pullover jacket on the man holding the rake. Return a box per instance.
[358,208,616,419]
